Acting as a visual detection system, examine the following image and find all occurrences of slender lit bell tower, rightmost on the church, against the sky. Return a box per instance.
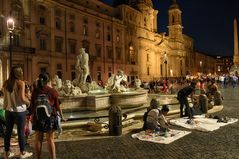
[168,0,183,39]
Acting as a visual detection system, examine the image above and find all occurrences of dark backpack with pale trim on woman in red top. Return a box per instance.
[35,94,54,132]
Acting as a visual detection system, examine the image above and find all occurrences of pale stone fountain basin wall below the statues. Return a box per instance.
[60,90,148,112]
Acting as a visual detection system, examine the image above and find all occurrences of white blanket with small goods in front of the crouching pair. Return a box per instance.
[131,129,191,144]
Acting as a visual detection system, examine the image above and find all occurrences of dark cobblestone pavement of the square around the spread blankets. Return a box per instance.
[1,88,239,159]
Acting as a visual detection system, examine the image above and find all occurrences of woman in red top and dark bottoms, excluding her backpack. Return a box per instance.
[31,73,60,159]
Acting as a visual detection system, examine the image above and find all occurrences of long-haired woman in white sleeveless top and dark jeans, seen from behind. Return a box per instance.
[3,66,32,159]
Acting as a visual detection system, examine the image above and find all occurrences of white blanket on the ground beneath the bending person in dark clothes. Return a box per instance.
[170,115,238,132]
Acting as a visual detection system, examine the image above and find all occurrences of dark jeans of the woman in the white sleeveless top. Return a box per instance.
[4,111,26,152]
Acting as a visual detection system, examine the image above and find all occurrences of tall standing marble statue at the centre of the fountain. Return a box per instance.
[75,48,90,84]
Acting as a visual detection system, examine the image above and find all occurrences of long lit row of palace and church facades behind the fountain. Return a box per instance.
[0,0,195,85]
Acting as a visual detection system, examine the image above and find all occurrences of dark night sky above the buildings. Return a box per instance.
[102,0,239,56]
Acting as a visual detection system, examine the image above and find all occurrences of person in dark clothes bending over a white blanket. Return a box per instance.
[177,81,196,120]
